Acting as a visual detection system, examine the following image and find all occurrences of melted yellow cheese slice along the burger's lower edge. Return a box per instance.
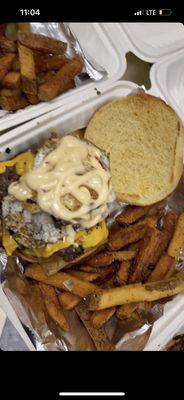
[3,221,109,258]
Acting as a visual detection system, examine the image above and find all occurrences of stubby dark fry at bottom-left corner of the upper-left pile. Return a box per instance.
[0,94,29,111]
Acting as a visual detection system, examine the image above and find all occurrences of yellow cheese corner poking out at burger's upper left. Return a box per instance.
[0,150,34,176]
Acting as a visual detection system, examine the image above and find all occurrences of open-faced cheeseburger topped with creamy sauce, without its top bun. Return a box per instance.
[0,135,115,269]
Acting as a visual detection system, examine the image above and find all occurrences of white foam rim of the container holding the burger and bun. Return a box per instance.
[0,81,184,350]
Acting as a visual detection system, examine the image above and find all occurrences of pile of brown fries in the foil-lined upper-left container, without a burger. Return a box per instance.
[0,23,83,111]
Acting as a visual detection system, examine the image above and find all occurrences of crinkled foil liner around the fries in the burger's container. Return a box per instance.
[0,177,184,351]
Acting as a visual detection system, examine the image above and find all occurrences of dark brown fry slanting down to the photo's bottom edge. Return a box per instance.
[76,302,114,351]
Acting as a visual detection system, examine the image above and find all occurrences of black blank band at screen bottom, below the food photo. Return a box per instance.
[0,352,183,400]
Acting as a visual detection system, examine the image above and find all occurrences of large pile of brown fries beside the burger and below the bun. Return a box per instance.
[25,206,184,350]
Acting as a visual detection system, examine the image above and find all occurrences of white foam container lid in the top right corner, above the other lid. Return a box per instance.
[103,22,184,63]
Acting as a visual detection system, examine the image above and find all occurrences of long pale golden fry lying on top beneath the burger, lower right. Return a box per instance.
[87,273,184,311]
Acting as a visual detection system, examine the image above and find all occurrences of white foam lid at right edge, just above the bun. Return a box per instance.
[149,50,184,123]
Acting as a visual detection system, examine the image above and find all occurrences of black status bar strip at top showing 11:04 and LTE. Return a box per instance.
[0,0,184,22]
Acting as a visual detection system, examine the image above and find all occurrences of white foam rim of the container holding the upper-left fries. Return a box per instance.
[0,23,126,132]
